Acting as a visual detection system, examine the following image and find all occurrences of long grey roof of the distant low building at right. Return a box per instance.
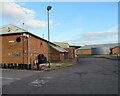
[79,43,118,49]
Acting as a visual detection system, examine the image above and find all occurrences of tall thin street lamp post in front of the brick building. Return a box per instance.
[47,6,52,68]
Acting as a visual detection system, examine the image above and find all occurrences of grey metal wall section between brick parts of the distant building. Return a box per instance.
[92,47,110,55]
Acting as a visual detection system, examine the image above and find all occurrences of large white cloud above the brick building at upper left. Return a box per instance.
[0,0,46,28]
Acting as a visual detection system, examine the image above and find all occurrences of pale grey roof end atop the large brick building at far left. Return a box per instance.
[0,24,28,34]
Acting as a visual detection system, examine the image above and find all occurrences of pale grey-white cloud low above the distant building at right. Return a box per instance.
[67,26,118,45]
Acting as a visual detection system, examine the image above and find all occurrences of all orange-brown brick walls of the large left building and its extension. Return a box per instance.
[0,34,66,64]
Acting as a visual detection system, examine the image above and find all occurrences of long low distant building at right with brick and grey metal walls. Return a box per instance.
[76,43,120,55]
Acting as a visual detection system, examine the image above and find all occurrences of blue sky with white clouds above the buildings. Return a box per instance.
[0,0,118,45]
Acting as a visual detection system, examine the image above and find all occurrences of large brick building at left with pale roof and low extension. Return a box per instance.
[0,25,68,65]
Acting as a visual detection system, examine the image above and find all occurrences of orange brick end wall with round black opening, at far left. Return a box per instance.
[2,35,23,63]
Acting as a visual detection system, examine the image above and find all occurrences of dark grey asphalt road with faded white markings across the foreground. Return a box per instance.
[2,58,118,94]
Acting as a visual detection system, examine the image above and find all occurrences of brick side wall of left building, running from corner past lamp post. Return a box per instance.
[25,36,65,64]
